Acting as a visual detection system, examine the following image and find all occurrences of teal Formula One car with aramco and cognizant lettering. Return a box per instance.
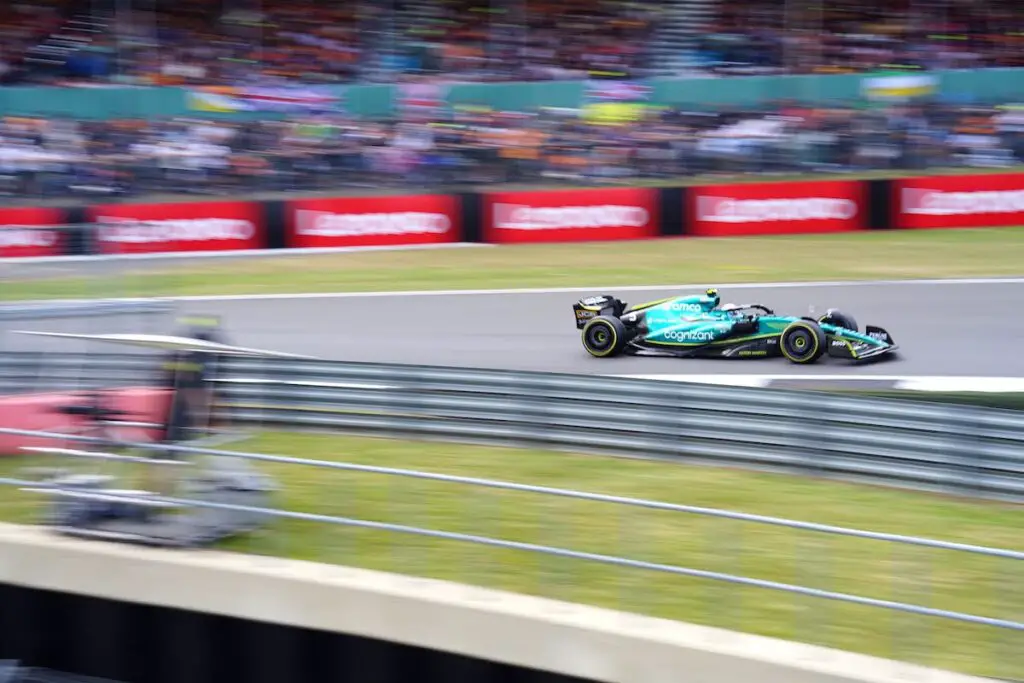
[572,289,898,364]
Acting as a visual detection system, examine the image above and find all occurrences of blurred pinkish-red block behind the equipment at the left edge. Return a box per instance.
[0,387,171,457]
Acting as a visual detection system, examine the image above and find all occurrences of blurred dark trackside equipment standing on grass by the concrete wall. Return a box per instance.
[6,319,311,547]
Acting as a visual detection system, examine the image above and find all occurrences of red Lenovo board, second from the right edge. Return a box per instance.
[684,180,867,237]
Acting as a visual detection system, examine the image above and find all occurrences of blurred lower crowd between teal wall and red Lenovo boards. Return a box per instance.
[0,97,1024,200]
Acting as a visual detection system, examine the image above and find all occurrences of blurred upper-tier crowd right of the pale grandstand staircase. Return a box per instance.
[697,0,1024,74]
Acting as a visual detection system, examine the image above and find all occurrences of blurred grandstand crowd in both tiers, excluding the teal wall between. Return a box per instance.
[0,0,1024,198]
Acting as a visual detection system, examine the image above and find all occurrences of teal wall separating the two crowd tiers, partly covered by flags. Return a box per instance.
[0,69,1024,119]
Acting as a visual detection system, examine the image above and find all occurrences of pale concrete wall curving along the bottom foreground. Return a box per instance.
[0,524,982,683]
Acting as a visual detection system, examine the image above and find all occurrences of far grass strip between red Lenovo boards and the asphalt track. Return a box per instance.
[6,227,1024,300]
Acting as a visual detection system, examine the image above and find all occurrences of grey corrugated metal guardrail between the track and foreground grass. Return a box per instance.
[0,353,1024,502]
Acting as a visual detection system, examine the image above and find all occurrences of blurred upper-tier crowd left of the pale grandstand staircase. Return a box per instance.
[4,0,657,85]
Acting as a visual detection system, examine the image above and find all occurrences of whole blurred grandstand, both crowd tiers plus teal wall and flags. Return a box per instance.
[0,0,1024,205]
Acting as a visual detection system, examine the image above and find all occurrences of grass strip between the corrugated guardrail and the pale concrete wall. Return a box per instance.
[0,433,1024,676]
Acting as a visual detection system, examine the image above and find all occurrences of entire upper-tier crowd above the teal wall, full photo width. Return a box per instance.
[0,0,1024,85]
